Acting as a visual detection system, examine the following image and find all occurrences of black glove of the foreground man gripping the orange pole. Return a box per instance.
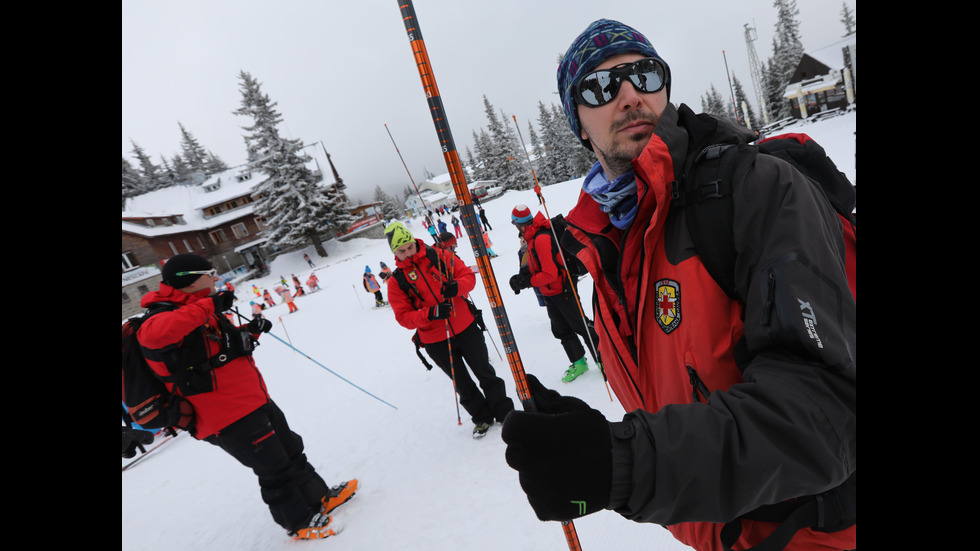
[501,375,612,521]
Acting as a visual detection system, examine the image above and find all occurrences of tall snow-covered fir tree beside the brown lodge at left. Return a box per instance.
[233,71,353,257]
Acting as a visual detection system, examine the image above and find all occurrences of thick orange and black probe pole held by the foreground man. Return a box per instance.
[398,0,582,551]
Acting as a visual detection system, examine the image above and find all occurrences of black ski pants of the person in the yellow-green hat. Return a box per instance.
[425,321,514,424]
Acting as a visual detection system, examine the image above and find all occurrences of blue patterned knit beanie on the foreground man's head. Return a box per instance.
[558,19,670,149]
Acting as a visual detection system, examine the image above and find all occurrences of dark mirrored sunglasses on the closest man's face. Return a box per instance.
[574,57,670,107]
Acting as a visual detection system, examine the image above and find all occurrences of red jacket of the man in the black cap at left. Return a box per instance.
[136,283,269,439]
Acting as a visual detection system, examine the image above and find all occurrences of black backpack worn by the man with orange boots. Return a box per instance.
[122,303,194,430]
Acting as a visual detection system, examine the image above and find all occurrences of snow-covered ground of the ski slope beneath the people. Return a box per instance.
[122,112,857,551]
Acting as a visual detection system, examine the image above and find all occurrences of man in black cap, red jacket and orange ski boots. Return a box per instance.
[137,254,357,539]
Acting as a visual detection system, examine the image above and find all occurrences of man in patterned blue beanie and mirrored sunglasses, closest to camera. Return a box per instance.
[502,20,856,551]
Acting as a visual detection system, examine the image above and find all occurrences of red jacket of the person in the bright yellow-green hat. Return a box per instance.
[385,239,476,344]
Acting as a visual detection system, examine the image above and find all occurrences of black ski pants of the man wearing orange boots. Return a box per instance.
[204,400,329,532]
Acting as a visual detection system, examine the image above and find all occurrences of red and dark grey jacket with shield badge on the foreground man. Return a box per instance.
[563,105,857,551]
